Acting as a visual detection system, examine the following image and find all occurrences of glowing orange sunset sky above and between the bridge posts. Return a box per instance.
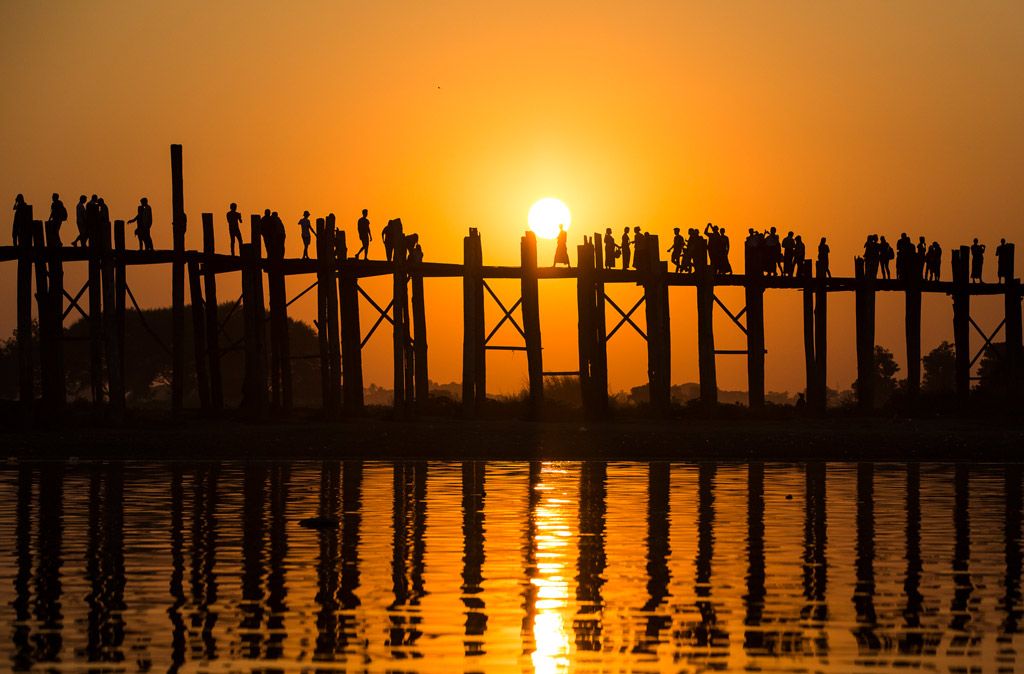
[0,1,1024,391]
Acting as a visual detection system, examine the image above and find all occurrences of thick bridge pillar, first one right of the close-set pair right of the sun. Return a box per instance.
[639,235,672,416]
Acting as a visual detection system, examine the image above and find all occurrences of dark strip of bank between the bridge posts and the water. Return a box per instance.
[0,418,1024,462]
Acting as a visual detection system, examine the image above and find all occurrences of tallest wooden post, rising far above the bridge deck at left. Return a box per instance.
[171,144,185,415]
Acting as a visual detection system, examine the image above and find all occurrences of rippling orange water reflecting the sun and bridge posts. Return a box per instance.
[0,461,1024,674]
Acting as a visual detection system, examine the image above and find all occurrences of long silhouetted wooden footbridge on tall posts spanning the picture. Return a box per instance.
[0,145,1024,423]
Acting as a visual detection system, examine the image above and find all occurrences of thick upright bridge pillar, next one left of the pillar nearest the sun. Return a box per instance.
[462,227,487,416]
